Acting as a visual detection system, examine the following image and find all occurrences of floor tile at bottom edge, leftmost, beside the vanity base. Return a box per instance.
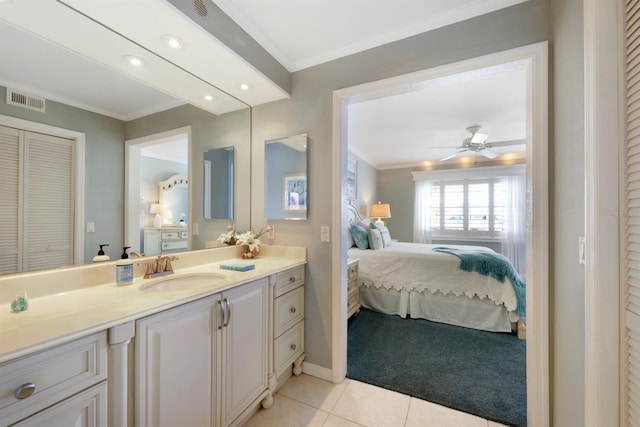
[244,394,329,427]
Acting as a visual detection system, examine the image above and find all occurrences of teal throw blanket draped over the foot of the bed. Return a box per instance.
[433,247,527,318]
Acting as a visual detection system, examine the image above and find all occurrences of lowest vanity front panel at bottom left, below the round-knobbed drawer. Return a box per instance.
[14,382,107,427]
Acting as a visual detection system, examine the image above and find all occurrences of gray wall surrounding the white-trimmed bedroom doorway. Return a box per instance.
[252,0,584,426]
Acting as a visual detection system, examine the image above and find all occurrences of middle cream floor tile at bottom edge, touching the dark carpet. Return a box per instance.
[332,380,411,427]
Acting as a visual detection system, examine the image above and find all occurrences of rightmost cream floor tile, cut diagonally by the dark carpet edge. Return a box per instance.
[406,398,488,427]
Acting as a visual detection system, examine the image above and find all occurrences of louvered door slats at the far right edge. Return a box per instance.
[621,0,640,426]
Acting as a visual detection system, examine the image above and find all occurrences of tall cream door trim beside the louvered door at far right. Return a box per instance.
[583,0,627,427]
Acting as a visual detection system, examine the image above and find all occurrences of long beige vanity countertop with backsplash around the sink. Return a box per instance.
[0,245,306,363]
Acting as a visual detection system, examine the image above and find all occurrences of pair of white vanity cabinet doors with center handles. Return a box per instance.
[134,279,269,427]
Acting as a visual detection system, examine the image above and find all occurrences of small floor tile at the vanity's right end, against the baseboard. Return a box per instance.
[278,374,349,412]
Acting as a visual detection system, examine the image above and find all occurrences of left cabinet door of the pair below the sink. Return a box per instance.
[135,296,219,427]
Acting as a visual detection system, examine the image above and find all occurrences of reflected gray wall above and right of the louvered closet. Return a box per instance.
[0,86,125,262]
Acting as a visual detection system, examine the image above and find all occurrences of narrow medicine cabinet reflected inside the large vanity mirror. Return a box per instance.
[204,147,235,219]
